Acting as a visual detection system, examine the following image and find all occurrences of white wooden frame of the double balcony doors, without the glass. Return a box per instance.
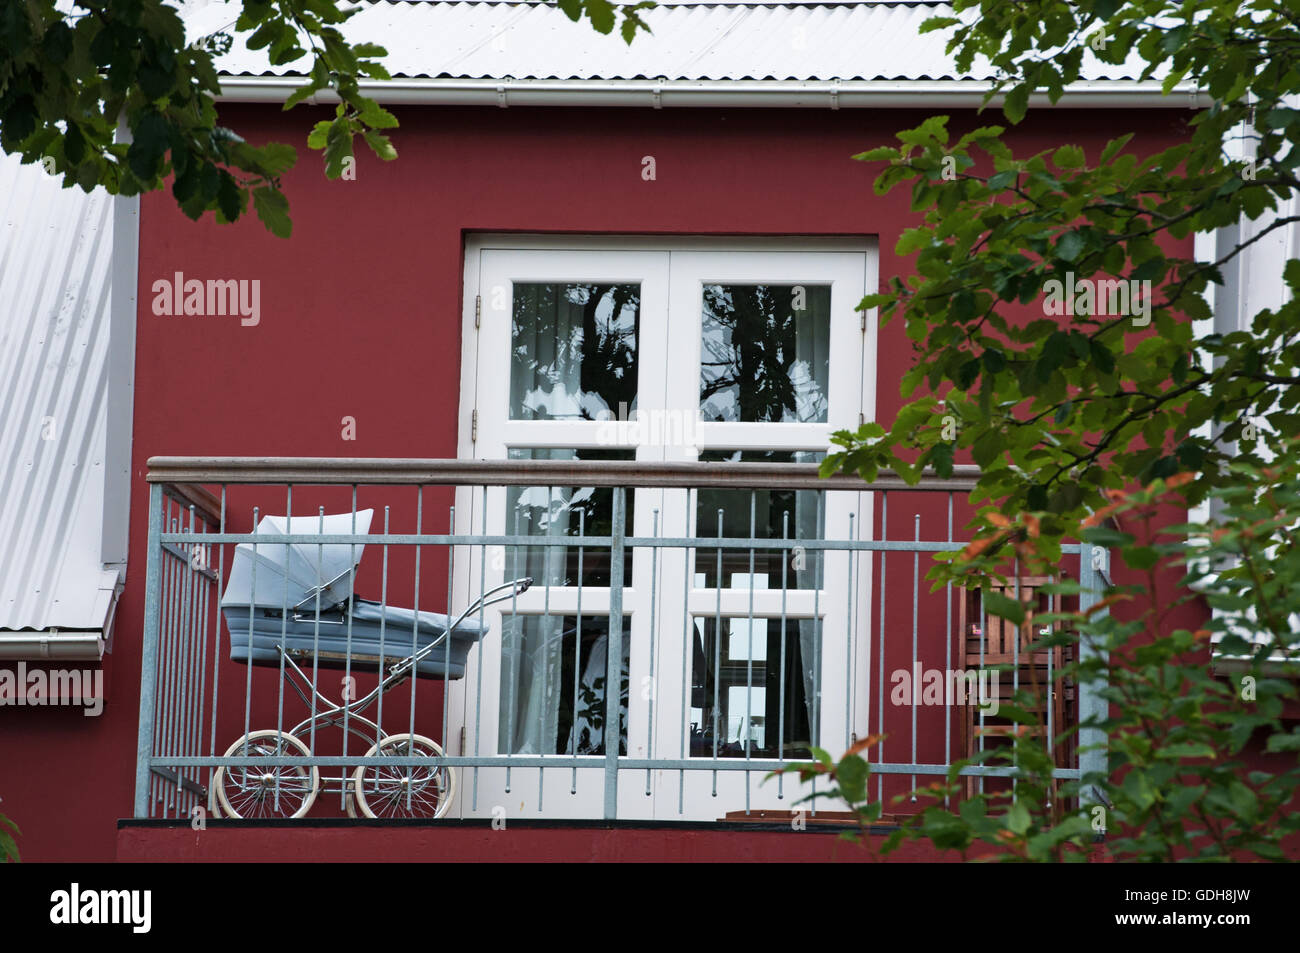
[449,235,878,819]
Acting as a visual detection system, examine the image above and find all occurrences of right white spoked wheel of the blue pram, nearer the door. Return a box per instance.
[352,733,456,819]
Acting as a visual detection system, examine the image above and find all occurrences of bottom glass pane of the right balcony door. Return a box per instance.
[690,618,818,758]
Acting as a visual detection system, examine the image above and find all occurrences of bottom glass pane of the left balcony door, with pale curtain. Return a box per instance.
[498,615,632,754]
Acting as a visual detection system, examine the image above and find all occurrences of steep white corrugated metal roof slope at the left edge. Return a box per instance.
[0,155,117,629]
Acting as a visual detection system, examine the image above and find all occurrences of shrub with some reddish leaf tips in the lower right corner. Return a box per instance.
[769,462,1300,861]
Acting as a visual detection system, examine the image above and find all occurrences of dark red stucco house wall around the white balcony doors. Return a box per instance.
[0,107,1206,859]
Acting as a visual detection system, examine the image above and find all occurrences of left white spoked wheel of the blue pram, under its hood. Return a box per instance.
[212,728,321,818]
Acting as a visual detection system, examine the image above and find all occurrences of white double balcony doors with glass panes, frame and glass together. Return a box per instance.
[450,237,876,819]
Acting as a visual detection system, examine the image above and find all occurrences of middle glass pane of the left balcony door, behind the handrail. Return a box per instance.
[506,447,636,589]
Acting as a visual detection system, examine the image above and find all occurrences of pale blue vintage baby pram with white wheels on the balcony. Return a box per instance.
[212,510,532,819]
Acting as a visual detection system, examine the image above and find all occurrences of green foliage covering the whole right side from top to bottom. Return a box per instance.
[774,0,1300,859]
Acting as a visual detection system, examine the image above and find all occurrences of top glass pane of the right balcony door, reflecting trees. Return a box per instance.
[699,285,831,424]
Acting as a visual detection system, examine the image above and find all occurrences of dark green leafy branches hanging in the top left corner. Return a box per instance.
[0,0,653,237]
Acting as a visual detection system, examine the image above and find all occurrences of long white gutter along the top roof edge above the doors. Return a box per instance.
[221,75,1210,109]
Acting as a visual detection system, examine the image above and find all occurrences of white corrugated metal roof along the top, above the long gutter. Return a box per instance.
[185,0,1141,82]
